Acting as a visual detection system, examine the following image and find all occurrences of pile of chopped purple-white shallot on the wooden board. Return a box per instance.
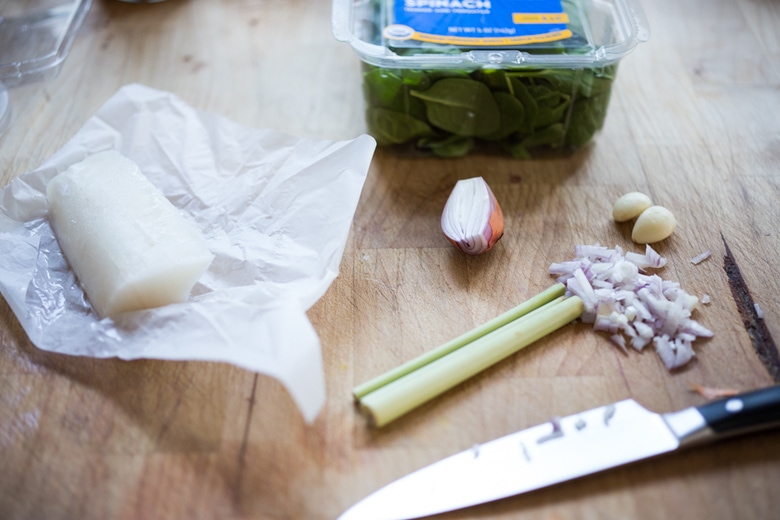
[550,245,712,370]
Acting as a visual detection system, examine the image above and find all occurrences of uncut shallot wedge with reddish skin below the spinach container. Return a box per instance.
[441,177,504,255]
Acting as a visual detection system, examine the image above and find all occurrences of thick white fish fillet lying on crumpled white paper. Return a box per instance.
[46,151,214,316]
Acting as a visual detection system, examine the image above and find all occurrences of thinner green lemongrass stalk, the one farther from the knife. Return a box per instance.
[352,283,566,401]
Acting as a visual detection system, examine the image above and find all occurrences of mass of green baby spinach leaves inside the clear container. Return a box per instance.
[363,64,616,158]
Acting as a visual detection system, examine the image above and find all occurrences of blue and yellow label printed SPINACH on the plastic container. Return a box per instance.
[383,0,572,46]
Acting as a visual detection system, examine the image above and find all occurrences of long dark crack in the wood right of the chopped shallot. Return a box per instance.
[721,235,780,383]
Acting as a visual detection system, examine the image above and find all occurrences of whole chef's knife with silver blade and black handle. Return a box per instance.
[338,386,780,520]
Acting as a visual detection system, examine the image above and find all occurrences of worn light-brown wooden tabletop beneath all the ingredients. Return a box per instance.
[0,0,780,520]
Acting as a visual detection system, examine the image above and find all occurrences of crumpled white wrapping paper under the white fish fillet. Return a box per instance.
[0,84,376,422]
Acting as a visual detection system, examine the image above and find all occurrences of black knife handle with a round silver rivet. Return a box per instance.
[696,385,780,434]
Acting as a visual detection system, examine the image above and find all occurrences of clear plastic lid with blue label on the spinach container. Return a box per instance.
[332,0,650,69]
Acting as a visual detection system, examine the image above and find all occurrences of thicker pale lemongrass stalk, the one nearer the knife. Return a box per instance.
[360,296,583,427]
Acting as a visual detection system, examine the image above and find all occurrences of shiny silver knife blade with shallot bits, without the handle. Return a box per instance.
[338,399,680,520]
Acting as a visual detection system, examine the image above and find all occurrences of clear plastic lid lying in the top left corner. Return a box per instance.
[0,0,92,88]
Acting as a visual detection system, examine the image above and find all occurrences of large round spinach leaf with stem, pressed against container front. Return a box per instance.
[410,78,501,137]
